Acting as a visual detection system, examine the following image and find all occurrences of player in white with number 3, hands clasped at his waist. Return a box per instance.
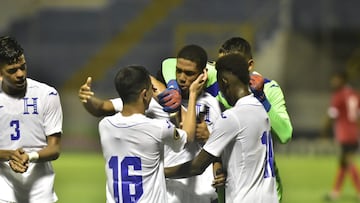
[0,36,63,203]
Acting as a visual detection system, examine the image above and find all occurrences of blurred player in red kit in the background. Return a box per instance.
[324,72,360,200]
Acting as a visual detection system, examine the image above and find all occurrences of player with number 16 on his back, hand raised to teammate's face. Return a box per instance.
[99,66,206,203]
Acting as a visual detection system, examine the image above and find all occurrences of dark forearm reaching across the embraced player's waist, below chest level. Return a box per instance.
[165,149,216,178]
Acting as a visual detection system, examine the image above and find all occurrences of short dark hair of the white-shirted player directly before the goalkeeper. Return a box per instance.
[215,53,250,85]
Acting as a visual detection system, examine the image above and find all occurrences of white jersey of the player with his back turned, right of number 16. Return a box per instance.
[204,94,278,203]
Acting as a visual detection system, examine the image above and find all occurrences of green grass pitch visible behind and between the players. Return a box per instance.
[53,152,356,203]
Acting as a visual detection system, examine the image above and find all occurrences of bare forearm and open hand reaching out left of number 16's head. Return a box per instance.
[79,77,116,117]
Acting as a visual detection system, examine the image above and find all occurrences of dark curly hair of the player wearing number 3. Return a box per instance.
[0,36,24,65]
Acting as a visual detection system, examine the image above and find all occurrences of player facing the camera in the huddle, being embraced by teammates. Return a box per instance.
[160,45,221,203]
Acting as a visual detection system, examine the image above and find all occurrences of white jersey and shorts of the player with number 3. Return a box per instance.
[0,78,63,203]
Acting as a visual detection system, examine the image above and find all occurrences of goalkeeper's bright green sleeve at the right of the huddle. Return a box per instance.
[264,81,293,143]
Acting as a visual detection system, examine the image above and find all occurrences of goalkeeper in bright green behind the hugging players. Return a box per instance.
[162,37,293,200]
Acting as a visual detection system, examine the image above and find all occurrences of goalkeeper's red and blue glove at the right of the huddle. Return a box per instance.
[250,73,271,112]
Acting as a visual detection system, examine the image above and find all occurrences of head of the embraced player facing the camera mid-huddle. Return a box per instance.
[176,44,208,98]
